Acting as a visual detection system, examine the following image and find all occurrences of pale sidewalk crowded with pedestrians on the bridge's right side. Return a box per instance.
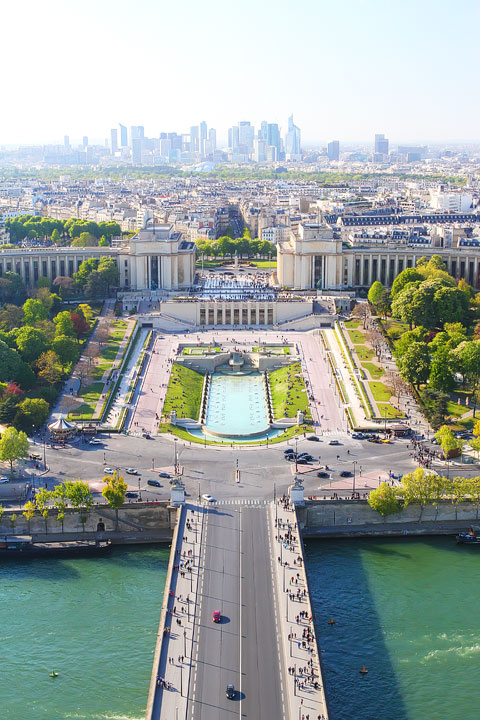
[269,500,328,720]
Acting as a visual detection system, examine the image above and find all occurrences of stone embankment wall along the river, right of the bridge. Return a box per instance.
[297,500,479,538]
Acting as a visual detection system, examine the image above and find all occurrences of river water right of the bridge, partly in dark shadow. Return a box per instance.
[306,537,480,720]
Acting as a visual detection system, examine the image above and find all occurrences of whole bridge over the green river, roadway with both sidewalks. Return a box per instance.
[146,499,328,720]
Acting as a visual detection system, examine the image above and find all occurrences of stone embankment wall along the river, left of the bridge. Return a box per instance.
[0,501,177,544]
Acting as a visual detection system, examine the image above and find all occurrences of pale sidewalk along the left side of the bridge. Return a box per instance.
[147,506,204,720]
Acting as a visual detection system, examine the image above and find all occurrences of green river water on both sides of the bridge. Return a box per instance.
[0,538,480,720]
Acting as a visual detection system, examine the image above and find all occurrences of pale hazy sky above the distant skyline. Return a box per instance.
[0,0,480,144]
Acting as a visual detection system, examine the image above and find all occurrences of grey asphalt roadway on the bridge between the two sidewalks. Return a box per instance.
[187,504,284,720]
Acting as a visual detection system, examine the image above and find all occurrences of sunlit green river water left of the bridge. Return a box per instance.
[0,546,169,720]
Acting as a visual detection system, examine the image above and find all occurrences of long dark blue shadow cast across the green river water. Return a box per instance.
[305,540,408,720]
